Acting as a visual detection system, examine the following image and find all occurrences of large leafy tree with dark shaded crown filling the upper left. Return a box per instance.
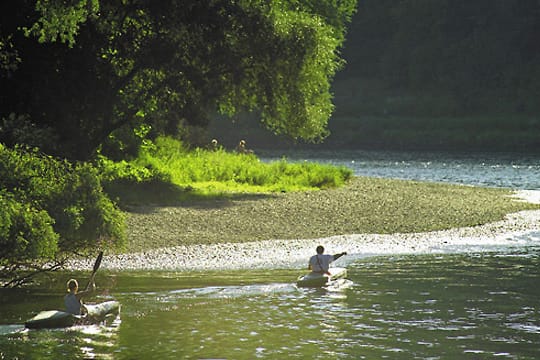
[0,0,356,159]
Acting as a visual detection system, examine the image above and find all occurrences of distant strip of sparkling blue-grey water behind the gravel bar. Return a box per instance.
[261,151,540,190]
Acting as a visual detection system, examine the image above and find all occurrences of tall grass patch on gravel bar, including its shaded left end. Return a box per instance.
[100,137,352,200]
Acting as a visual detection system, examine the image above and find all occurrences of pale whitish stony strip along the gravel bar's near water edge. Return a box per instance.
[67,191,540,271]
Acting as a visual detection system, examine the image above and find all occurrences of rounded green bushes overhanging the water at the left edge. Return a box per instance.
[0,146,125,260]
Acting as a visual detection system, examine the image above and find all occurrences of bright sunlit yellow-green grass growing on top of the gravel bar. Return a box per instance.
[137,138,352,192]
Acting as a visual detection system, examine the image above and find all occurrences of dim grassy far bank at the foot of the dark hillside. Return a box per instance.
[205,112,540,154]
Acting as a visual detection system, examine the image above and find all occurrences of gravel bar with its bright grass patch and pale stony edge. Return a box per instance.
[88,139,540,271]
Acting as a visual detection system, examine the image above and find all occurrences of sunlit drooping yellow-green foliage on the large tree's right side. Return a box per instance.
[223,1,355,141]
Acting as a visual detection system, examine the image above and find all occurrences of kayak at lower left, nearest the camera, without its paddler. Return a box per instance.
[24,301,120,329]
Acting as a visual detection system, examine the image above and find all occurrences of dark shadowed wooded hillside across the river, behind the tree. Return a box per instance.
[209,0,540,151]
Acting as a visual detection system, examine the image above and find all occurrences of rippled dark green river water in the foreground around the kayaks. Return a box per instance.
[0,247,540,359]
